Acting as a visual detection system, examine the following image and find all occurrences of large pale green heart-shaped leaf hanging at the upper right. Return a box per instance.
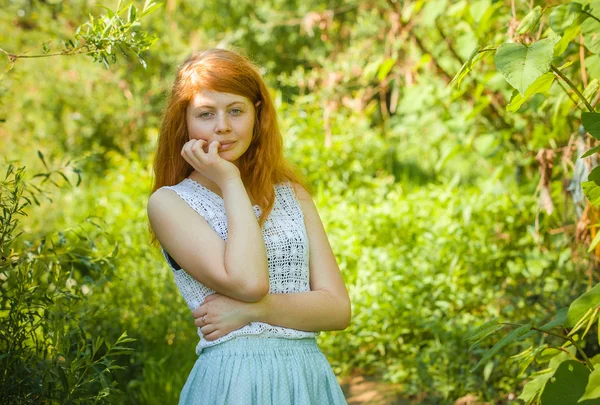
[494,38,555,95]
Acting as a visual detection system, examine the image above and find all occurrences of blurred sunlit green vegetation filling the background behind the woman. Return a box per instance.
[0,0,600,404]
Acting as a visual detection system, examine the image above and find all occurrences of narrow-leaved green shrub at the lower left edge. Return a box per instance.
[0,160,134,404]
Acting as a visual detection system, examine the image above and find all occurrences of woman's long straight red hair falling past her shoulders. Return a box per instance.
[148,49,307,245]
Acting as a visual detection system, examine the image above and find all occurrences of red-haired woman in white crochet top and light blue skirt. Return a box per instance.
[148,49,351,405]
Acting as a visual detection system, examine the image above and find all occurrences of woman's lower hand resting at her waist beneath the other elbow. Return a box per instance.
[192,293,251,340]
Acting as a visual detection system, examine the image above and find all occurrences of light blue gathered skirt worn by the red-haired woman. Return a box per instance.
[179,335,347,405]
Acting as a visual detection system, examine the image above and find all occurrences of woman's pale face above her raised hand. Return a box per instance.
[186,90,255,165]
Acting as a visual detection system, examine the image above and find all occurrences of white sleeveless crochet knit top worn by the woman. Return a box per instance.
[161,178,320,355]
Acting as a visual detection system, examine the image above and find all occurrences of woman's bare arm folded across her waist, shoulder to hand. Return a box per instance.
[192,185,352,336]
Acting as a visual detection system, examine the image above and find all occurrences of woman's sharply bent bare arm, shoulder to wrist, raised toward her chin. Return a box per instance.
[147,178,269,302]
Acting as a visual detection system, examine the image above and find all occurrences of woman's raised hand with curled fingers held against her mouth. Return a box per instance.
[181,139,240,187]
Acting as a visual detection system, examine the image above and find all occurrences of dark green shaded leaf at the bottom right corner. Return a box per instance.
[541,360,600,405]
